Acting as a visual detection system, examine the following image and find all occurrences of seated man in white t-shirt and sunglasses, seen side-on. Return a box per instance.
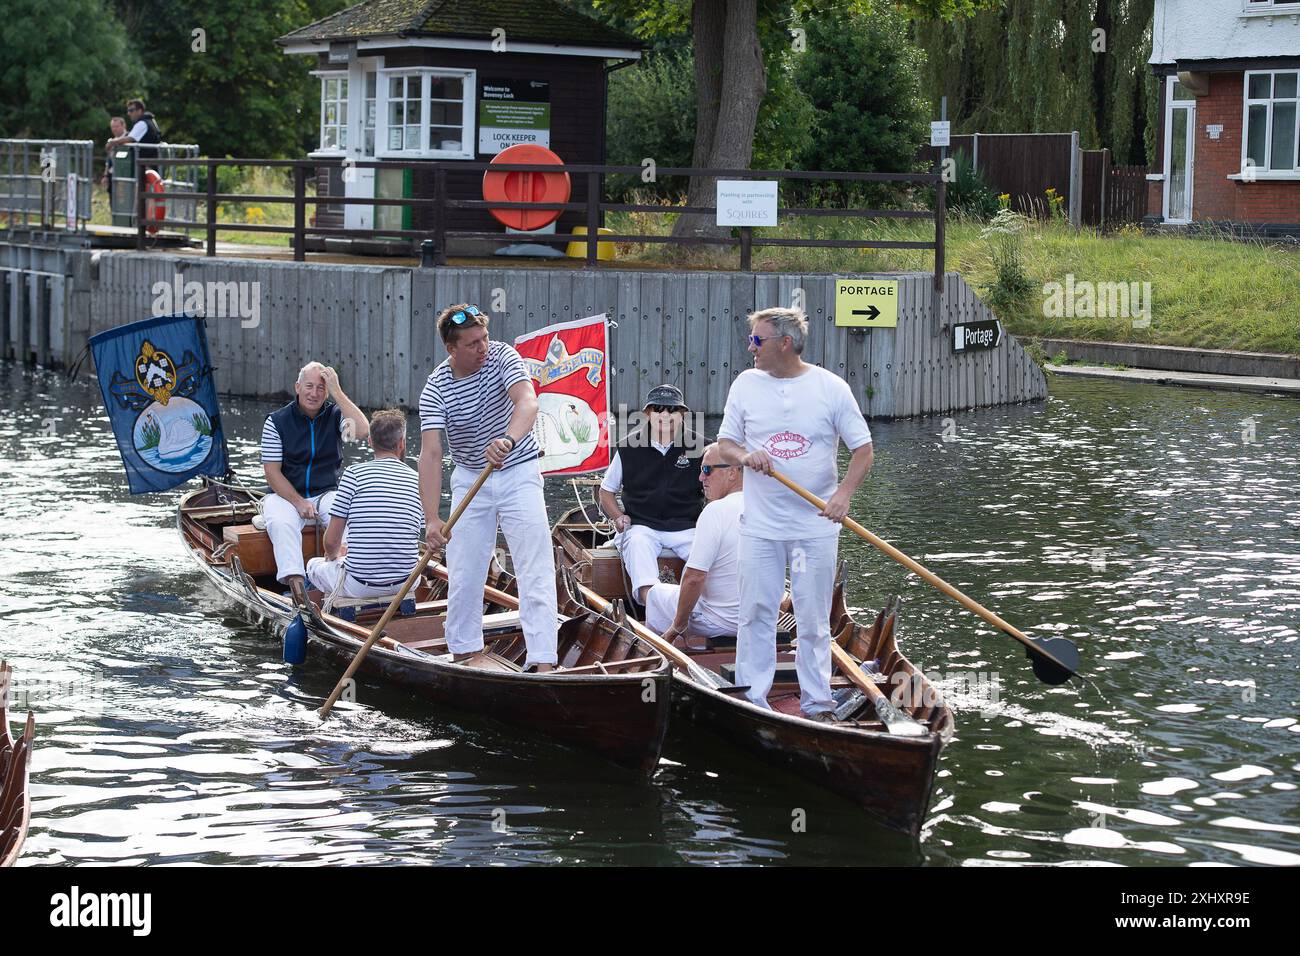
[646,444,745,650]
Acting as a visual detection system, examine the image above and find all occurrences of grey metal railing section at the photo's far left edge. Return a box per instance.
[0,139,95,230]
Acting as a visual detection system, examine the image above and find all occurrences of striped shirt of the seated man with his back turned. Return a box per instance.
[329,458,424,587]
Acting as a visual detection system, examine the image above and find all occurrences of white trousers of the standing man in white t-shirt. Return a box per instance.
[736,532,840,717]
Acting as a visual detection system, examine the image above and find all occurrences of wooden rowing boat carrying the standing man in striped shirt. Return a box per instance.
[177,484,671,777]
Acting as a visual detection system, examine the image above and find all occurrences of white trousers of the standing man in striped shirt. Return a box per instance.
[446,462,558,666]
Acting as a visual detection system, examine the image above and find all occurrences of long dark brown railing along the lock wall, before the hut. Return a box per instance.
[137,159,946,283]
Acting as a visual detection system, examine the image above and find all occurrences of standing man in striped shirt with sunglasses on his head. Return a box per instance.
[420,304,556,672]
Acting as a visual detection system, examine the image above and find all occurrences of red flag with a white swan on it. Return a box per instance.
[515,312,610,475]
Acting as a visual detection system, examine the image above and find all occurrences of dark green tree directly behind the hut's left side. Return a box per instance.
[109,0,351,157]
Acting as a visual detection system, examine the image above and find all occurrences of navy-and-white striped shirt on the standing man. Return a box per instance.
[420,342,540,471]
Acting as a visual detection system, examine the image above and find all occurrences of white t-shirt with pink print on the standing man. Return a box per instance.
[718,365,871,541]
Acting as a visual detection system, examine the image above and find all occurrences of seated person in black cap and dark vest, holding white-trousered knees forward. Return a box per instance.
[599,385,705,605]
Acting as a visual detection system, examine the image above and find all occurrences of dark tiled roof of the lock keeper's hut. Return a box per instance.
[278,0,642,49]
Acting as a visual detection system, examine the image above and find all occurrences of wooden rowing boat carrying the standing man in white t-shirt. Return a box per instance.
[553,506,953,835]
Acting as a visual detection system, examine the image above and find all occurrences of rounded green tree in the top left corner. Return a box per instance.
[0,0,143,143]
